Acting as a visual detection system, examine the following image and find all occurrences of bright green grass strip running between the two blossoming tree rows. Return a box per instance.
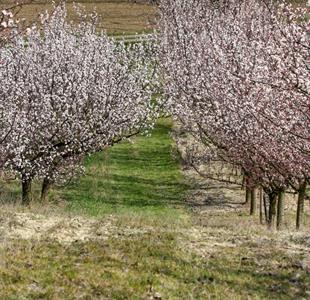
[61,120,186,216]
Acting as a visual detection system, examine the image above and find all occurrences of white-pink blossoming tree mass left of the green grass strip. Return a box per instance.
[0,6,155,204]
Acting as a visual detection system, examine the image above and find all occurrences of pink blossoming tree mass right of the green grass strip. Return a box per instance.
[159,0,310,227]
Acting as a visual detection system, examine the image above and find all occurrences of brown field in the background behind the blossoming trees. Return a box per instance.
[0,1,156,35]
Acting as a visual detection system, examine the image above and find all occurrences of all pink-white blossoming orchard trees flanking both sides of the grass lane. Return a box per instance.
[0,0,310,228]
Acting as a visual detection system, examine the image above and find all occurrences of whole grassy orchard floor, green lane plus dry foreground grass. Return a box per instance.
[0,119,310,299]
